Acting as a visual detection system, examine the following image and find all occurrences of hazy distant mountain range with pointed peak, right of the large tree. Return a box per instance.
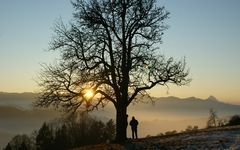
[129,96,240,119]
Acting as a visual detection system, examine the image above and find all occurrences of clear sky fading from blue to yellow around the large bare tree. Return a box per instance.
[0,0,240,104]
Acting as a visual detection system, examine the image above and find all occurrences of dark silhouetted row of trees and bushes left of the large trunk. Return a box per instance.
[5,115,115,150]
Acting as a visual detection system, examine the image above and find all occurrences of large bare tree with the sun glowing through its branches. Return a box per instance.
[36,0,190,141]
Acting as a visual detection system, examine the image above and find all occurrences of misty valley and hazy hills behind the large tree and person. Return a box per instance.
[0,92,240,147]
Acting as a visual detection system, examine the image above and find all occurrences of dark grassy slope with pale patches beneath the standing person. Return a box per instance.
[73,126,240,150]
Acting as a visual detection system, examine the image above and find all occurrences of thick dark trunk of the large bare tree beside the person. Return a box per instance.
[116,104,128,143]
